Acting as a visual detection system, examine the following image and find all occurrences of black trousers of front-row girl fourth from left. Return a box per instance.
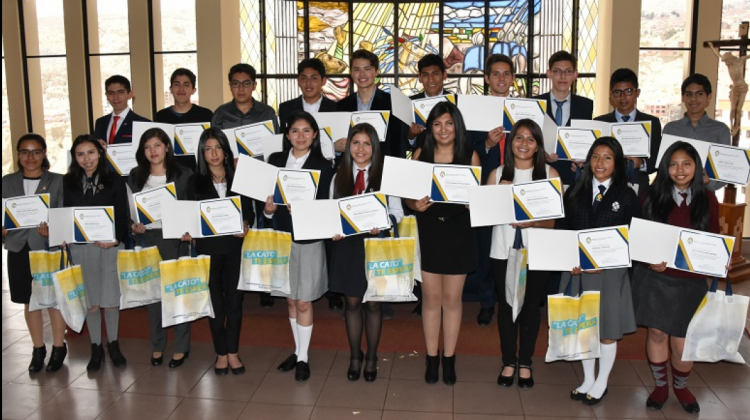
[208,250,245,356]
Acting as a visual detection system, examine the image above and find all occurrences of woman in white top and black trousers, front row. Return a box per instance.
[487,119,558,388]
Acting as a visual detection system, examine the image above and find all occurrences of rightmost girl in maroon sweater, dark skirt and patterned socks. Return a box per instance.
[633,141,719,413]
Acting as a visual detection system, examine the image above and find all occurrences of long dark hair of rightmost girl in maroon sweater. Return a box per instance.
[643,141,710,230]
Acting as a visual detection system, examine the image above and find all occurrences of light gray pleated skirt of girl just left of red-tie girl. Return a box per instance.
[272,241,328,302]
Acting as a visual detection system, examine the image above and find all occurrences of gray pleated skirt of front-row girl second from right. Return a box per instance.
[560,268,637,340]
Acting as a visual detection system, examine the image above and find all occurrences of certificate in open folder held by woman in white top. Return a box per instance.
[511,178,565,222]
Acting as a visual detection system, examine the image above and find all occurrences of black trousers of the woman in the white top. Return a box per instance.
[491,259,550,366]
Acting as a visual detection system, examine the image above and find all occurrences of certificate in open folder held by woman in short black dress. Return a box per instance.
[430,164,482,204]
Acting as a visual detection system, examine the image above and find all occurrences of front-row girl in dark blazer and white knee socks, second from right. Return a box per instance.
[556,137,641,405]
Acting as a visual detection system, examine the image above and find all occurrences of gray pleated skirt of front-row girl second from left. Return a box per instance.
[68,244,125,309]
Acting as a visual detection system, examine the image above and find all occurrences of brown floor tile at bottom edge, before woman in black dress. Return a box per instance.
[385,379,453,413]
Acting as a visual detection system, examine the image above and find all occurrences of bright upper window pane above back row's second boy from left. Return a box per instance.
[156,0,196,51]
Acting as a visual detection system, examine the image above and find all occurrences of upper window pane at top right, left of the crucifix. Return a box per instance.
[641,0,690,48]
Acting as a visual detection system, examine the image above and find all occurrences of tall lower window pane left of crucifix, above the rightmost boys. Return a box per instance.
[638,51,690,126]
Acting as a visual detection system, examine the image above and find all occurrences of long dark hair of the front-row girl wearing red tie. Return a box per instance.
[333,123,383,198]
